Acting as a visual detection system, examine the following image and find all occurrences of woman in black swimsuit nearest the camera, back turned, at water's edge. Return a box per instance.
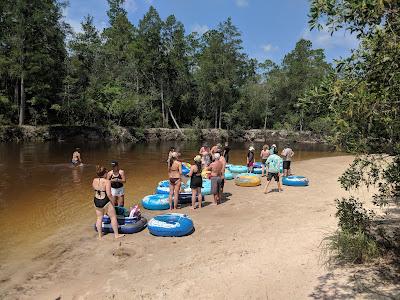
[92,166,124,239]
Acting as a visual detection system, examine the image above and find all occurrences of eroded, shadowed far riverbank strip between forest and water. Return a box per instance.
[0,125,324,143]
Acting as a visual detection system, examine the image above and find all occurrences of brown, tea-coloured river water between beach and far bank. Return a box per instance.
[0,142,339,260]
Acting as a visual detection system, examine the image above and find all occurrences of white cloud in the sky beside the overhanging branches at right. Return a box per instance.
[301,27,359,49]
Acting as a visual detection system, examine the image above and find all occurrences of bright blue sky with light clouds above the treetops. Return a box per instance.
[65,0,358,62]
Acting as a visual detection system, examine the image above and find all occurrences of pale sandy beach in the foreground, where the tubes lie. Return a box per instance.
[0,156,396,299]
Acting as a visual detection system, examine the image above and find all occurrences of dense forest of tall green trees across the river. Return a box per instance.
[0,0,333,131]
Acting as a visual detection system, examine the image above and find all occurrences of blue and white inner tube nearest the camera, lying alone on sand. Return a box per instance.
[148,213,194,236]
